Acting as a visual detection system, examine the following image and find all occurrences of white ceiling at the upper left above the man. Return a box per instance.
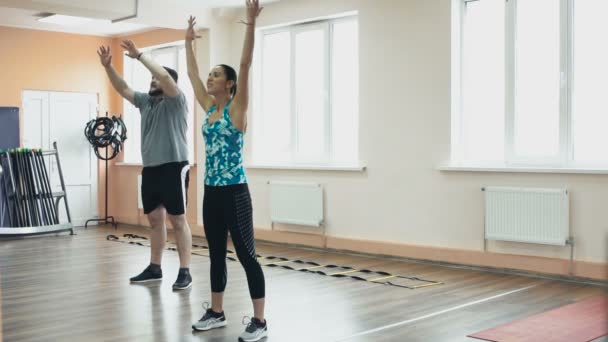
[0,0,279,37]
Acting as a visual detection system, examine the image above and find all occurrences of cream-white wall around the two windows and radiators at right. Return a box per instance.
[205,0,608,262]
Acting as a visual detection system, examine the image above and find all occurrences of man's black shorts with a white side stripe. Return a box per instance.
[141,161,190,215]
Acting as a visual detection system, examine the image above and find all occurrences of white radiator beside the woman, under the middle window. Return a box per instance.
[268,181,323,227]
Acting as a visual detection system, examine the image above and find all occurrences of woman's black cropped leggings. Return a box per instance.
[203,184,265,299]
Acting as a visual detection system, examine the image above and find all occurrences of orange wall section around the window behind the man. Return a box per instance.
[109,29,198,233]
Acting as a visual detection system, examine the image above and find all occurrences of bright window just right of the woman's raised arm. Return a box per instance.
[252,17,359,165]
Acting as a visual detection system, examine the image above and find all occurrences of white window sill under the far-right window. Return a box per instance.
[437,164,608,175]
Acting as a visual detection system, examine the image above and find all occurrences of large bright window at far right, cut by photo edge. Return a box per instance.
[452,0,608,167]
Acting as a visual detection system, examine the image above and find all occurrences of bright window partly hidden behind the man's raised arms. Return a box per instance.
[123,42,195,164]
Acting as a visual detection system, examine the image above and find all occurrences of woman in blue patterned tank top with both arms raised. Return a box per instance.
[186,0,267,341]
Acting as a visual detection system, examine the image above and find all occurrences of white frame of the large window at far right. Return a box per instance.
[451,0,608,168]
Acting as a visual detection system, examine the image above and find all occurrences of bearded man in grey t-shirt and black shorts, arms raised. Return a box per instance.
[97,40,192,290]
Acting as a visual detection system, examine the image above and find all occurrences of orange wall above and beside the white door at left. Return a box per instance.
[0,26,115,219]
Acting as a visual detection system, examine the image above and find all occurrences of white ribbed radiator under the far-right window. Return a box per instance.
[484,187,570,246]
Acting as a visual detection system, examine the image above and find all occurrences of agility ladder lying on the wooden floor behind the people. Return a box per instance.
[106,234,443,290]
